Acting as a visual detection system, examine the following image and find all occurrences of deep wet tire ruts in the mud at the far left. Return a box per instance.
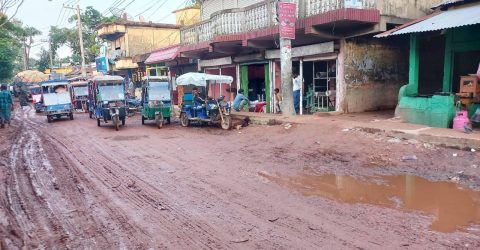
[4,108,152,249]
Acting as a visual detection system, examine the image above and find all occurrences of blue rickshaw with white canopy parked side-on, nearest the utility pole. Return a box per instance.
[177,73,233,130]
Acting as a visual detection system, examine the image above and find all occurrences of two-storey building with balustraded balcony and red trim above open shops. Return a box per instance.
[180,0,441,112]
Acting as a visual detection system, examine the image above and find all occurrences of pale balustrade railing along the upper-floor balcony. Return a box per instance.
[180,0,376,45]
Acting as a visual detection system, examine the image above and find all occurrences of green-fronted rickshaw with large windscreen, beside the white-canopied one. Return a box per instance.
[141,76,172,128]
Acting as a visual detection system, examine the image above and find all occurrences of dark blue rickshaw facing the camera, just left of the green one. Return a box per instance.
[89,76,127,131]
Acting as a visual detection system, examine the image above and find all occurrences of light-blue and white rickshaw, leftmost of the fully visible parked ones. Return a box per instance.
[40,80,73,123]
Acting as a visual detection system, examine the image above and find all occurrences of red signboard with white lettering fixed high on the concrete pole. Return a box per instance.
[278,2,297,40]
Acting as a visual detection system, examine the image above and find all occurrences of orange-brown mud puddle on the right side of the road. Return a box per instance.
[259,172,480,233]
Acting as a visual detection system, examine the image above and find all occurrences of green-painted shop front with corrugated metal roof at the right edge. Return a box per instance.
[377,3,480,128]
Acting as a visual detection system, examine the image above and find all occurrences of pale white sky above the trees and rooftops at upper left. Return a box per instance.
[15,0,186,58]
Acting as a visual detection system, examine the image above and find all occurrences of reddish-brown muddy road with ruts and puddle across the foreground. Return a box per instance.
[0,105,480,249]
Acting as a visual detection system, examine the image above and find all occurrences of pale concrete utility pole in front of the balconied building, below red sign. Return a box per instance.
[277,0,295,116]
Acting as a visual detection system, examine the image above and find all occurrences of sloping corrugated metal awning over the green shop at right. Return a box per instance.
[375,5,480,37]
